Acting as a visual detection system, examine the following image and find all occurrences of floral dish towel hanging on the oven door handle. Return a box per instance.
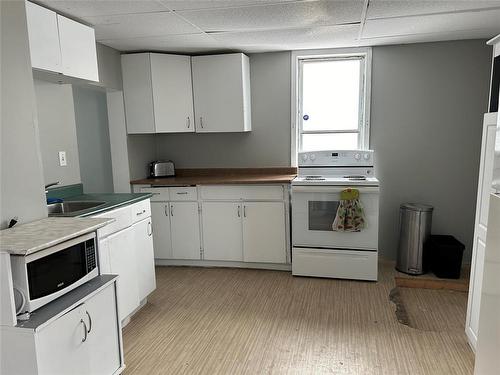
[332,188,366,232]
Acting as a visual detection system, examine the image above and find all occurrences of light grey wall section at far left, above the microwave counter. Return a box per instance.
[0,1,47,228]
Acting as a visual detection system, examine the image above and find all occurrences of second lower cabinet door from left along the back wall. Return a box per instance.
[170,202,200,259]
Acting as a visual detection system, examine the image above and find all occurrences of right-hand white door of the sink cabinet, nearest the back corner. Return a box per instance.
[132,217,156,301]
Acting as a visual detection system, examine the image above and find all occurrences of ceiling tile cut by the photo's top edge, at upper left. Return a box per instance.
[39,0,166,18]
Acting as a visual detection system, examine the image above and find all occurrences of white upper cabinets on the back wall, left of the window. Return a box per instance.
[122,53,251,134]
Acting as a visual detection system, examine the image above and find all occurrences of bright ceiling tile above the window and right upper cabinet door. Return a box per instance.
[211,25,359,52]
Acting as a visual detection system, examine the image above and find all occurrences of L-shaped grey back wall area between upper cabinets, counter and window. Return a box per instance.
[157,52,290,168]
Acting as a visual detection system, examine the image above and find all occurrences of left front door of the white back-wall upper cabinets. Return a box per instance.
[151,53,194,133]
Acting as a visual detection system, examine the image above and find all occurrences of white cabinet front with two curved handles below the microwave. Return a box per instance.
[34,283,122,375]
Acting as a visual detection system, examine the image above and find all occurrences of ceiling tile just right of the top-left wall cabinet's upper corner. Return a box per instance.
[84,12,200,40]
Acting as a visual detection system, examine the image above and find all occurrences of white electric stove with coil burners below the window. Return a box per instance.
[292,150,379,281]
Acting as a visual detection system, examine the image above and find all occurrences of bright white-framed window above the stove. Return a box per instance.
[292,49,371,160]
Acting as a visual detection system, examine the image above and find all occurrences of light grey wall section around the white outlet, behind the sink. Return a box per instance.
[35,80,81,185]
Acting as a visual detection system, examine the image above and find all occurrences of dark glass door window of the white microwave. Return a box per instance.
[27,244,87,300]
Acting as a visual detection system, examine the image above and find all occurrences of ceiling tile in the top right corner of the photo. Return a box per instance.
[366,0,500,19]
